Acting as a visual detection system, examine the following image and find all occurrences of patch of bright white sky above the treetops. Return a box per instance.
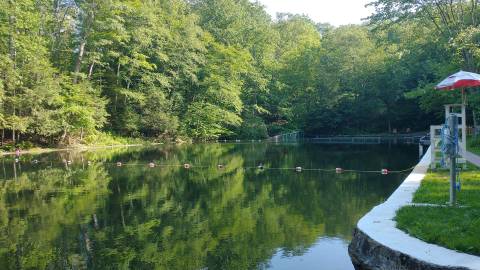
[259,0,372,26]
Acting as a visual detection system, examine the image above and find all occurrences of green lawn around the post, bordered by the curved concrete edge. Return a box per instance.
[396,170,480,255]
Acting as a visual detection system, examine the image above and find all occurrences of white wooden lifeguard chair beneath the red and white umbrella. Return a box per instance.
[430,104,467,169]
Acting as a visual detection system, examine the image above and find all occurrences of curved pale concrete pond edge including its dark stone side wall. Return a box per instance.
[349,151,480,269]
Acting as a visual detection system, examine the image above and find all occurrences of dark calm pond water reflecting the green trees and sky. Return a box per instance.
[0,144,417,269]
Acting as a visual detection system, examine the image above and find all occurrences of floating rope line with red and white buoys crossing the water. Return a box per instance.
[10,159,415,175]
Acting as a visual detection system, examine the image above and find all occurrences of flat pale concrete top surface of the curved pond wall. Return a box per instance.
[357,151,480,269]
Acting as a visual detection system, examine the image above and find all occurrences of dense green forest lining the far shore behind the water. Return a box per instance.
[0,0,480,145]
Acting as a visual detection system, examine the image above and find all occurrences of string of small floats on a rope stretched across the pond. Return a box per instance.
[8,158,415,175]
